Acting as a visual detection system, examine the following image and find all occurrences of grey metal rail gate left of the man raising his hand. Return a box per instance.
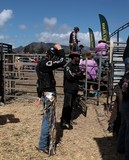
[2,49,44,103]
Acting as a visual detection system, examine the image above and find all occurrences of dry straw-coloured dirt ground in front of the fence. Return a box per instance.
[0,73,122,160]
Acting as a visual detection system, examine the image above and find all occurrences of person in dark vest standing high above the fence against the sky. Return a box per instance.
[69,27,79,53]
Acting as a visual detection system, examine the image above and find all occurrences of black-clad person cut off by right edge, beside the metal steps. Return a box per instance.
[123,36,129,72]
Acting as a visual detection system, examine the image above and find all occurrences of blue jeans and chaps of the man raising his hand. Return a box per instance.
[39,92,56,149]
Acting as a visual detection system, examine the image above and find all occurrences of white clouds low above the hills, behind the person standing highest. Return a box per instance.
[36,17,101,46]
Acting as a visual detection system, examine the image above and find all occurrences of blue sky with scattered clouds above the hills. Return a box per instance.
[0,0,129,48]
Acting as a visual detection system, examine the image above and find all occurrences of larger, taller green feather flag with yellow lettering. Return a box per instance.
[99,14,109,41]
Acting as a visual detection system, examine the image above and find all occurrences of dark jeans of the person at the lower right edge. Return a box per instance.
[117,102,129,160]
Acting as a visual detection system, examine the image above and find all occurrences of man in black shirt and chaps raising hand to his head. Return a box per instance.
[34,44,66,155]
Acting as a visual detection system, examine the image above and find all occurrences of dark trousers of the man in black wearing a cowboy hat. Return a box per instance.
[61,93,77,124]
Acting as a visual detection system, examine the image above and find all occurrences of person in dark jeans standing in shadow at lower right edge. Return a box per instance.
[117,63,129,160]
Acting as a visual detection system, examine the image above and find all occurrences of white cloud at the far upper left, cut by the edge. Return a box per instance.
[0,9,13,28]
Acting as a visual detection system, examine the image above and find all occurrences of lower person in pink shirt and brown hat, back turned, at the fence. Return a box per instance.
[80,51,98,96]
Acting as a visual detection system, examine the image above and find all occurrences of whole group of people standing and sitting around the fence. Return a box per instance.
[35,27,129,160]
